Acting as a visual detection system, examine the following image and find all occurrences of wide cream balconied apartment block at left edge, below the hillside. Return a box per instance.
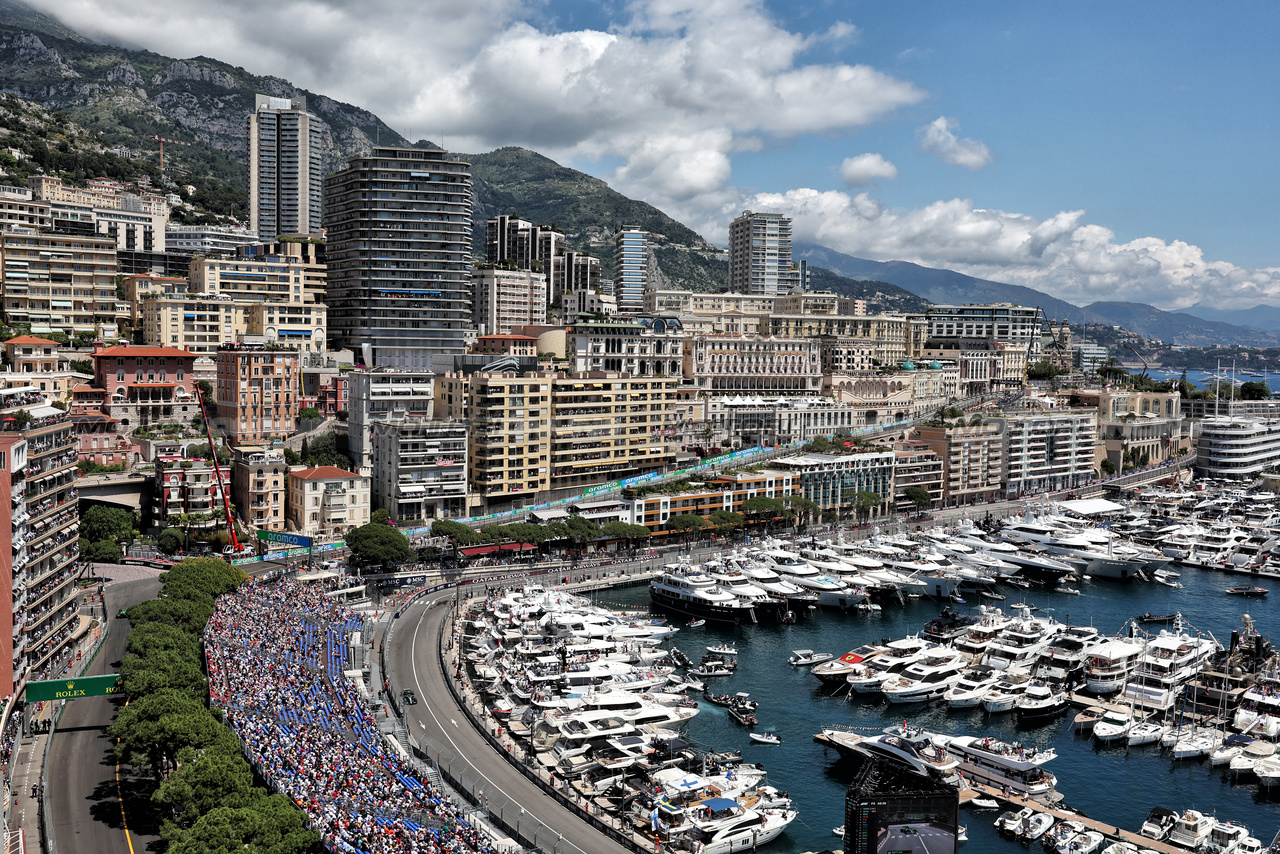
[0,230,120,335]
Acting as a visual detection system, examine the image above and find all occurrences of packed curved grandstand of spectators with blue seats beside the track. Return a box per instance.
[206,581,493,854]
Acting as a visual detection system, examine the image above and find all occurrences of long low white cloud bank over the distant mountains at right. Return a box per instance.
[742,189,1280,310]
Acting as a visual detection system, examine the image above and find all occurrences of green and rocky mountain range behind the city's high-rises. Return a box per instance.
[0,0,1280,347]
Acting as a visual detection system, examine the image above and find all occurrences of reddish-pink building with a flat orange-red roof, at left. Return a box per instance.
[92,343,200,431]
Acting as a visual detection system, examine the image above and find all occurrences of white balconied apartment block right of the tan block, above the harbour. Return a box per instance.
[988,410,1098,498]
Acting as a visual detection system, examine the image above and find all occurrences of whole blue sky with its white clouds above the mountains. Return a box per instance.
[35,0,1280,309]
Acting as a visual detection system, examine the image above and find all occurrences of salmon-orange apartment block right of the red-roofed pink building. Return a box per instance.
[216,342,301,444]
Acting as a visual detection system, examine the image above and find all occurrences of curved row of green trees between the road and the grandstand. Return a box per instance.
[108,558,319,854]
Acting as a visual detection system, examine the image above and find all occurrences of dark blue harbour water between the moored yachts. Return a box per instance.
[596,567,1280,854]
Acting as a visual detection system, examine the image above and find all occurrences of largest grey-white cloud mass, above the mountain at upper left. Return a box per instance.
[33,0,924,205]
